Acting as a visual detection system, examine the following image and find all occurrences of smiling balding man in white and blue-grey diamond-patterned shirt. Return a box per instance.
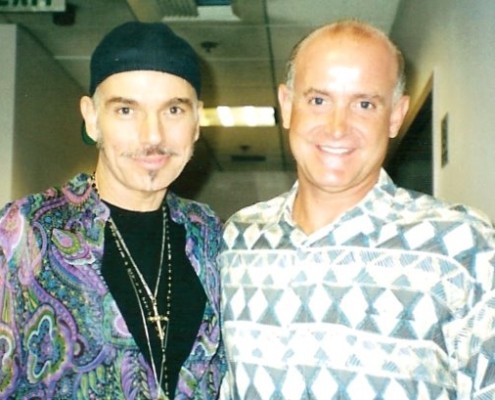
[219,21,495,400]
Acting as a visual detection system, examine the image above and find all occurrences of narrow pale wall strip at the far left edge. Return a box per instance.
[0,25,17,205]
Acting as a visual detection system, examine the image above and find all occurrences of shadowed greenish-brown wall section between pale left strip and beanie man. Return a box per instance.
[12,28,95,198]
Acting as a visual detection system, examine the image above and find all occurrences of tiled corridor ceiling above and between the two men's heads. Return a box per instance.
[0,0,401,176]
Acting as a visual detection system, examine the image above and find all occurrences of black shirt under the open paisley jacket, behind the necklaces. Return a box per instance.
[102,203,206,398]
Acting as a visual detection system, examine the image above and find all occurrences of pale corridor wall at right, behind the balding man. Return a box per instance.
[391,0,495,219]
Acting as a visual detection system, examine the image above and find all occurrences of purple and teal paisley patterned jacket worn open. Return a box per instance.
[0,174,225,400]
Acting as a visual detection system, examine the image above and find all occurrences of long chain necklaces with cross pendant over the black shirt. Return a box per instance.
[90,174,172,397]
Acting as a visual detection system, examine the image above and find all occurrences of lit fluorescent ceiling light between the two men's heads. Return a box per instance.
[200,106,275,127]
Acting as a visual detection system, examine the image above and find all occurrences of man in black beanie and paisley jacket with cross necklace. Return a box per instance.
[0,22,225,399]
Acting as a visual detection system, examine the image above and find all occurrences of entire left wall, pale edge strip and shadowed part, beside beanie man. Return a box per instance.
[0,24,96,205]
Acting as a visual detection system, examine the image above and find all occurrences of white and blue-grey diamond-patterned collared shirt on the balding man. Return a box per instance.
[219,170,495,400]
